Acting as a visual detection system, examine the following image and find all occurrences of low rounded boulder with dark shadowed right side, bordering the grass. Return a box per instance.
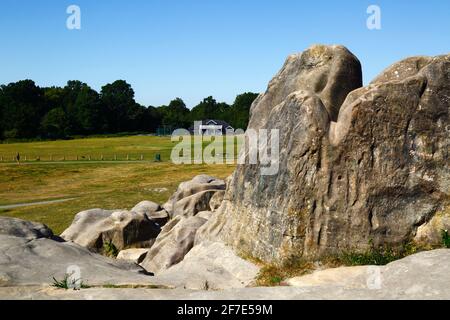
[61,209,161,252]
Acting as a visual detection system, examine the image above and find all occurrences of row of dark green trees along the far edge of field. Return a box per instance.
[0,80,258,139]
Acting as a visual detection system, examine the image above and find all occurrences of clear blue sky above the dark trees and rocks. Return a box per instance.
[0,0,450,107]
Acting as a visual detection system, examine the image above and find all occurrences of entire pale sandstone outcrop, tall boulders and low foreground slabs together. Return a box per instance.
[0,45,450,299]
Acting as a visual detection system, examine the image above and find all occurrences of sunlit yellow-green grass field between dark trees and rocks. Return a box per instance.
[0,136,234,234]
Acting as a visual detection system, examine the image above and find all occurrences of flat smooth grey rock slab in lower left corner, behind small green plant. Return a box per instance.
[0,218,161,287]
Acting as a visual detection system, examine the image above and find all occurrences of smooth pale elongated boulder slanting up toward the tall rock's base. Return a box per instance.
[141,216,207,274]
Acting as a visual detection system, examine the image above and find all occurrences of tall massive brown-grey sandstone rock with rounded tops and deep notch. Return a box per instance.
[200,46,450,261]
